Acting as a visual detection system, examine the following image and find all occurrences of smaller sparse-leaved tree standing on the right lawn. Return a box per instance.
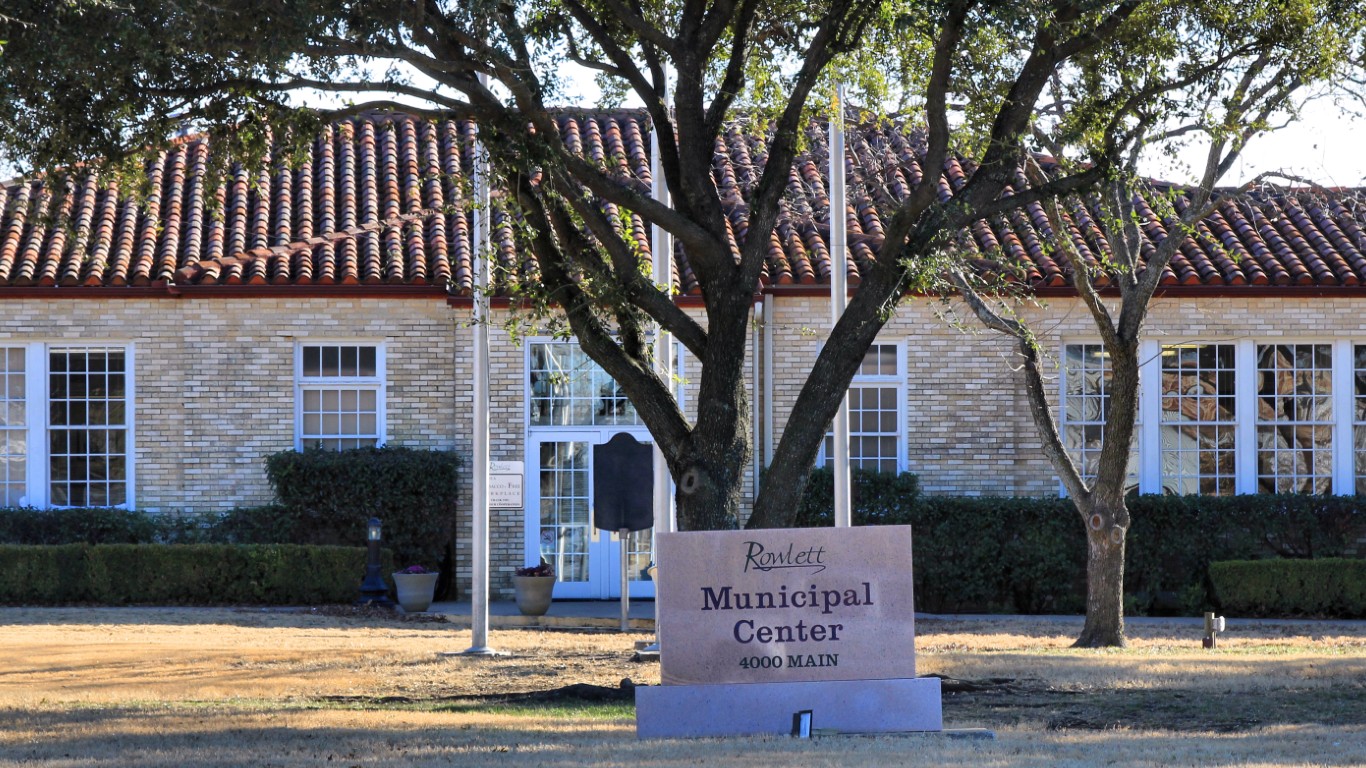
[949,3,1363,646]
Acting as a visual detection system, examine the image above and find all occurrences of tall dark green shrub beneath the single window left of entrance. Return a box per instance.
[263,448,460,597]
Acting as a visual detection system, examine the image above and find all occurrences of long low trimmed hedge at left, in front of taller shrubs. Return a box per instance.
[0,544,393,605]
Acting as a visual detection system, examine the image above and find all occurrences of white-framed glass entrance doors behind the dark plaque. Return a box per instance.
[526,428,654,599]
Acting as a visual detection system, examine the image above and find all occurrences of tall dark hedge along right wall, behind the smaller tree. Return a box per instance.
[798,470,1366,615]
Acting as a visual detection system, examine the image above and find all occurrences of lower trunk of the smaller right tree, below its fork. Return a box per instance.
[1072,500,1128,648]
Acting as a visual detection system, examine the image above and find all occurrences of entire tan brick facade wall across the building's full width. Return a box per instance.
[0,289,1366,596]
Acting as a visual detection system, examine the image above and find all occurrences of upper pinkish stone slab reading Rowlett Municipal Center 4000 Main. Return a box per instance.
[656,526,915,685]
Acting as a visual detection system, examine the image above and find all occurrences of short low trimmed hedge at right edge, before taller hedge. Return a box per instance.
[1209,558,1366,618]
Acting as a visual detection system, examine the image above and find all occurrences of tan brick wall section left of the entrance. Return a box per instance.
[0,297,469,512]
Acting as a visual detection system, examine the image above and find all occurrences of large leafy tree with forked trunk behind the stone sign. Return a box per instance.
[0,0,1360,645]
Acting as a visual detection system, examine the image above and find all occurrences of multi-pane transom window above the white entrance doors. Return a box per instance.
[529,342,641,426]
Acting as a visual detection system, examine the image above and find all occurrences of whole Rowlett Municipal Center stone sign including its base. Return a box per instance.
[637,526,943,738]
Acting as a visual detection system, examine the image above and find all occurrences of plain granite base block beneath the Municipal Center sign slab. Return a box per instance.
[635,678,944,739]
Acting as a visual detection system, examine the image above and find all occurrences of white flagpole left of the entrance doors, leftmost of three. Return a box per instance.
[464,74,496,656]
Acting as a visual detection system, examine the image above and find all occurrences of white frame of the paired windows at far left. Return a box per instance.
[0,339,138,510]
